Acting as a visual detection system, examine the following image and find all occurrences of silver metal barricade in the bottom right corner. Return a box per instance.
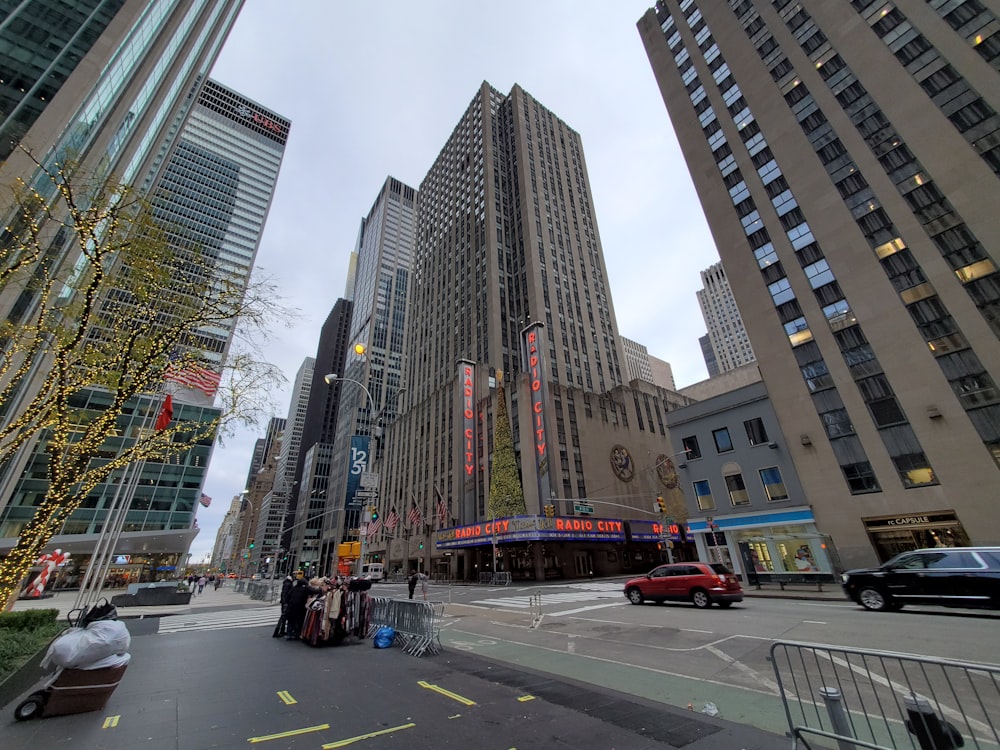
[768,641,1000,750]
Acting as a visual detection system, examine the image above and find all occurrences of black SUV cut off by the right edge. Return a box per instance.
[842,547,1000,611]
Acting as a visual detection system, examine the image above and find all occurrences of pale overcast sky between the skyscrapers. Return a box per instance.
[191,0,718,561]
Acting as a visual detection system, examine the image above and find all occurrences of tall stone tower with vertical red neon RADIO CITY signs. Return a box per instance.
[368,82,696,580]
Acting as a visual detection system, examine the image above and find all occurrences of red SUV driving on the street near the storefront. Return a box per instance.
[625,562,743,609]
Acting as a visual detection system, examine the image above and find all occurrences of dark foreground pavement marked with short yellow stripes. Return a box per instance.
[0,610,788,750]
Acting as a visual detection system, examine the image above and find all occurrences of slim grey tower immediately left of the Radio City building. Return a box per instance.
[323,177,417,560]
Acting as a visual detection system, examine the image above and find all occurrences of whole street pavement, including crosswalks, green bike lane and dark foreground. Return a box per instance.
[0,580,1000,750]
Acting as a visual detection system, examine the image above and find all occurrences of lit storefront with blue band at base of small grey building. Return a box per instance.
[688,507,840,584]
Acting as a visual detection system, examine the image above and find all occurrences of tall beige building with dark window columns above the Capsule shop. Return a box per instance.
[638,0,1000,566]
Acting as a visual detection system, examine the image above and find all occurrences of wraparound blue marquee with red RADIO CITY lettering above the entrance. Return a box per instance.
[434,516,625,549]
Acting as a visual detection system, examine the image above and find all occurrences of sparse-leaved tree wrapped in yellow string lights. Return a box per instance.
[0,153,293,609]
